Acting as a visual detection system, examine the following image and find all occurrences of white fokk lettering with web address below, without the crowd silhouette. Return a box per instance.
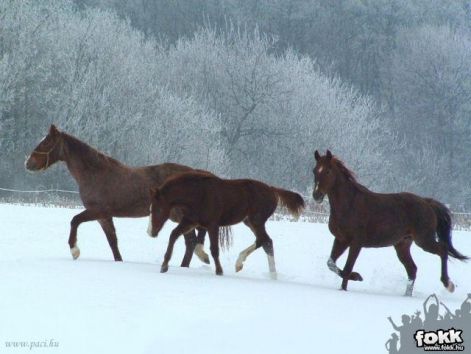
[414,328,464,351]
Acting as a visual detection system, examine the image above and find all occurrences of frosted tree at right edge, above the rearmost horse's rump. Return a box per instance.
[392,26,471,207]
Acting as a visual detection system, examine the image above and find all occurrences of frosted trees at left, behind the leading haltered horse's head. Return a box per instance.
[0,1,223,191]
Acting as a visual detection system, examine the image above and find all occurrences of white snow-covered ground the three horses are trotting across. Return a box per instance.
[0,205,471,354]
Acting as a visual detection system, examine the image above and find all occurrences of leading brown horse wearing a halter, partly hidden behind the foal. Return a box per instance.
[25,125,209,267]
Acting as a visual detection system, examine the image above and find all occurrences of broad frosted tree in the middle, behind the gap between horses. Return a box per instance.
[155,27,391,191]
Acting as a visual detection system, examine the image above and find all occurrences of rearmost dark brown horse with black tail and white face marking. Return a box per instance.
[313,150,468,296]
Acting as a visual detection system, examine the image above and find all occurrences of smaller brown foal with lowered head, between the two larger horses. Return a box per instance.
[148,172,304,278]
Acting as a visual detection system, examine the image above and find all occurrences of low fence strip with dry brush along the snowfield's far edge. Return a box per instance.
[0,187,471,231]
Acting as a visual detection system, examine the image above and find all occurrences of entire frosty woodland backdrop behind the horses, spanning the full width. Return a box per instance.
[0,0,471,209]
